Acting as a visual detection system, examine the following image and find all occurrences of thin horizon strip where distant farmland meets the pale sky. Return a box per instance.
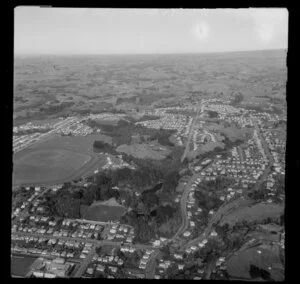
[14,47,288,56]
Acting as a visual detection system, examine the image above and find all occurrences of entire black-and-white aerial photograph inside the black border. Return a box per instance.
[10,6,288,281]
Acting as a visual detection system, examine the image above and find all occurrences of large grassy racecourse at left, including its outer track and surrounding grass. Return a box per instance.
[13,134,111,185]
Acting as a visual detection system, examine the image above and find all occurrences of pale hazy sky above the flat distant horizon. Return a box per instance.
[14,7,288,54]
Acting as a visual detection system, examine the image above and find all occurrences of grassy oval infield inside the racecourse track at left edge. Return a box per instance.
[13,149,91,184]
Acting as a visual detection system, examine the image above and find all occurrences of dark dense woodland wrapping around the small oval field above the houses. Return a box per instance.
[38,153,180,242]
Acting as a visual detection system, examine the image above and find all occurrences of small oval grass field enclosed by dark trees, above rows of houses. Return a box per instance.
[81,201,126,222]
